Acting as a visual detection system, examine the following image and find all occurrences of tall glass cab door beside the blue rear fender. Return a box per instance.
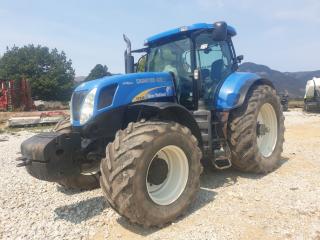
[195,33,233,109]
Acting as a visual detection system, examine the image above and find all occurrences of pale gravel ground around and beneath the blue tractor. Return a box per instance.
[0,110,320,240]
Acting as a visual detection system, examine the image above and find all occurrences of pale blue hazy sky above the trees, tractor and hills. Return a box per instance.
[0,0,320,76]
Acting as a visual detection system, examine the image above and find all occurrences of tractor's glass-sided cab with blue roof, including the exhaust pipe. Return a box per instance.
[125,22,241,110]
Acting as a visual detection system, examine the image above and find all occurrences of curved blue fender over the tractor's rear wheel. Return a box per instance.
[214,72,274,111]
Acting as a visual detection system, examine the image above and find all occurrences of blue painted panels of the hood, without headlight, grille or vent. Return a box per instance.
[72,72,175,126]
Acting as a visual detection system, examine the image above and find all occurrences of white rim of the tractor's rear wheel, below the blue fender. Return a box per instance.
[257,103,278,157]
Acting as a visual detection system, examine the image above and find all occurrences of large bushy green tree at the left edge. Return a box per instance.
[0,45,75,101]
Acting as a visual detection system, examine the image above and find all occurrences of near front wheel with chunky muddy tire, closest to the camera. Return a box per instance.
[100,120,202,227]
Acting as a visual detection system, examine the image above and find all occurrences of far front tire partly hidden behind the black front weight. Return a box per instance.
[52,118,100,190]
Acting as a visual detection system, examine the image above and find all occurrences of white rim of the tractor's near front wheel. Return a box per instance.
[146,145,189,205]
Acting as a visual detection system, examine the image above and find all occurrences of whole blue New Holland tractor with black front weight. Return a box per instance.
[19,22,284,227]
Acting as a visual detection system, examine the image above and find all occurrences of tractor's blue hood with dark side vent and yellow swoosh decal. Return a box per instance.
[71,72,175,126]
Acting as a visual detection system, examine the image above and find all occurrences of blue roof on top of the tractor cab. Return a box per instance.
[144,23,237,46]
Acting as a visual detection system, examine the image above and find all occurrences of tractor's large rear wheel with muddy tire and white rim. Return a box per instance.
[228,85,285,173]
